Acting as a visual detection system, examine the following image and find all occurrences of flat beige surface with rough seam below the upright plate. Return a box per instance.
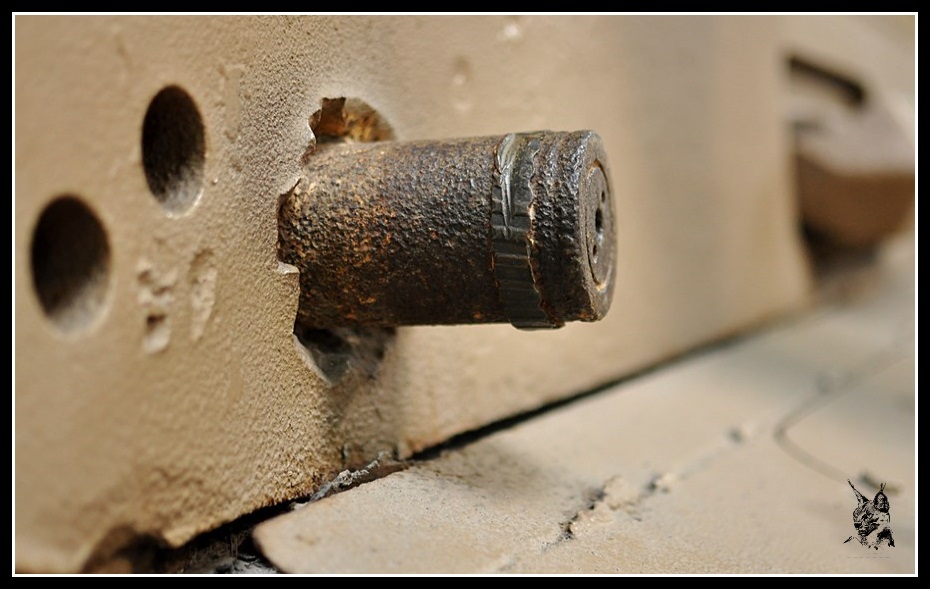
[163,235,917,574]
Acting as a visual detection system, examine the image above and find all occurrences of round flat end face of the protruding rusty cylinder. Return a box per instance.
[579,134,617,320]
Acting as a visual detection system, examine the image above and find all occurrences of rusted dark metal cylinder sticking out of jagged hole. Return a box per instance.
[279,131,616,329]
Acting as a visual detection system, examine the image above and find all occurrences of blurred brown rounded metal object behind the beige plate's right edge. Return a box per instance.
[790,57,915,248]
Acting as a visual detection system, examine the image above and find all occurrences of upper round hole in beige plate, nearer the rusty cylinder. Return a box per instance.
[142,86,206,214]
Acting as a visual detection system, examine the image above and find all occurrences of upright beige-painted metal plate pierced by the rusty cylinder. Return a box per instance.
[13,16,908,571]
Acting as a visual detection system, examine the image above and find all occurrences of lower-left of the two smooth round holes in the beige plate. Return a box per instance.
[31,196,110,332]
